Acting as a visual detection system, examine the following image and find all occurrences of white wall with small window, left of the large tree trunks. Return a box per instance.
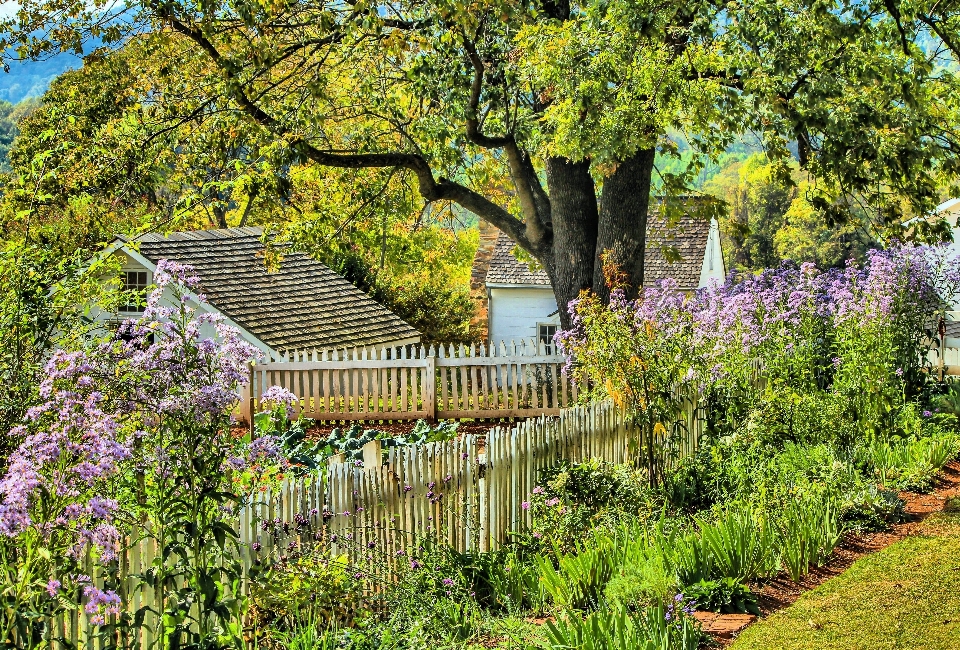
[487,287,560,343]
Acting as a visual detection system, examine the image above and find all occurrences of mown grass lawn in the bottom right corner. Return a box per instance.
[732,499,960,650]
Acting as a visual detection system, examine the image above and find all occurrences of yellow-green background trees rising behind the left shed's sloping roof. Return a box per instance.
[0,39,476,343]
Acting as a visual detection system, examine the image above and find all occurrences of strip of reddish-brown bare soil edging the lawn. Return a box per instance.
[698,461,960,646]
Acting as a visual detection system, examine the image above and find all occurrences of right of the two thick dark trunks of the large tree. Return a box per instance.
[593,149,655,301]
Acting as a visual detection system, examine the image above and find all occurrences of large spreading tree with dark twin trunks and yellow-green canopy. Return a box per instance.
[2,0,960,324]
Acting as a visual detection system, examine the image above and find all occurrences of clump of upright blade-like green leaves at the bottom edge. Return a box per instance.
[541,606,702,650]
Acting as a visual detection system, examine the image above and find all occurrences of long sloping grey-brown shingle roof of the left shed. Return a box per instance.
[130,228,420,351]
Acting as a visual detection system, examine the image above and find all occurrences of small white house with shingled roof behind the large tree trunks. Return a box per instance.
[472,215,726,345]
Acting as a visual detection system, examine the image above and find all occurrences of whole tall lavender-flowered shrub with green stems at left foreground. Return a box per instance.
[0,261,288,647]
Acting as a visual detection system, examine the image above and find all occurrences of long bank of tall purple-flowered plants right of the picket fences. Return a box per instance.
[557,246,960,460]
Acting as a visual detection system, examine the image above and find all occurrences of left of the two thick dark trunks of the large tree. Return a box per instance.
[542,158,599,329]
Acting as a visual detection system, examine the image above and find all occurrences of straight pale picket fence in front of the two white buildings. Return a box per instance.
[242,341,578,422]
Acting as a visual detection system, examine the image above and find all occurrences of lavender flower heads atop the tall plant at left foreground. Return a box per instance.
[0,260,278,623]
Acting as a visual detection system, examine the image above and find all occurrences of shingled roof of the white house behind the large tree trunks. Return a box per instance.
[487,214,711,291]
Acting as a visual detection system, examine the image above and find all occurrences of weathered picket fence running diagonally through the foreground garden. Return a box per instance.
[43,400,703,650]
